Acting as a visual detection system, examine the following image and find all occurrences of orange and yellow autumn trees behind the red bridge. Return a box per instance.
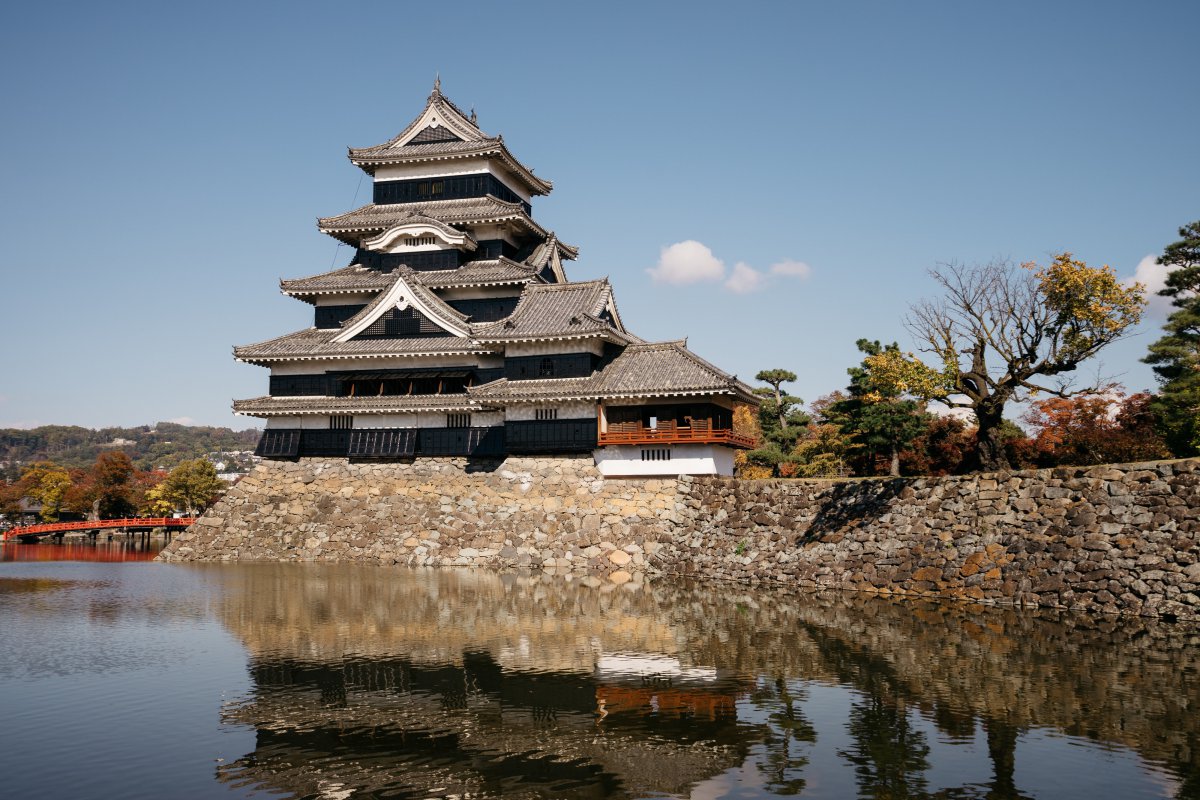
[0,451,226,522]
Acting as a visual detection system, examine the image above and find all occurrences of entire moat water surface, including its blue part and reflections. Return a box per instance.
[0,542,1200,800]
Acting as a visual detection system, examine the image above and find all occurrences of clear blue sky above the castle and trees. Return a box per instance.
[0,0,1200,428]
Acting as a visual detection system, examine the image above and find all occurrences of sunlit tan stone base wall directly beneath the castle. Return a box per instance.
[160,455,678,582]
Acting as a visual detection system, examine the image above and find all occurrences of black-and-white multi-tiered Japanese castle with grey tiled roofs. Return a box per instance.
[234,82,758,476]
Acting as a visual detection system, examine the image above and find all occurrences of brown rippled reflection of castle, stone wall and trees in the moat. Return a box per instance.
[211,565,1200,798]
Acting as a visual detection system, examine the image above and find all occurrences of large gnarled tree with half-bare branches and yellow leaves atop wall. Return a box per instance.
[868,253,1144,470]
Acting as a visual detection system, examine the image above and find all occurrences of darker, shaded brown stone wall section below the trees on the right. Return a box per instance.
[654,461,1200,619]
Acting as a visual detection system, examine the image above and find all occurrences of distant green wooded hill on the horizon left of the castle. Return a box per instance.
[0,422,259,479]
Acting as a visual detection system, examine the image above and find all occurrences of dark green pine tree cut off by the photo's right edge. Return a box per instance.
[1142,221,1200,457]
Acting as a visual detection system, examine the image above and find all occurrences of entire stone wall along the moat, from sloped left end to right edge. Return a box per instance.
[161,456,1200,620]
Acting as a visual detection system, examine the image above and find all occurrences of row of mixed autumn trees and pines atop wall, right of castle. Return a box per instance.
[734,222,1200,477]
